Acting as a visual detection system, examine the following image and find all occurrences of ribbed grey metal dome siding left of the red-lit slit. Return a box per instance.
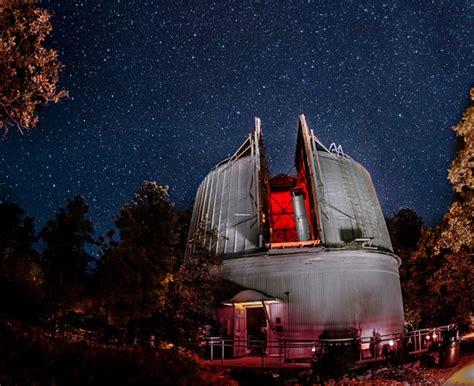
[190,156,260,254]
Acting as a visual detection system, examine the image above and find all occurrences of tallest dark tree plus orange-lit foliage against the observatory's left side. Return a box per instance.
[98,181,222,349]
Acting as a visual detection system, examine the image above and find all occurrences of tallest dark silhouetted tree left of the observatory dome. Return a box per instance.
[98,181,178,338]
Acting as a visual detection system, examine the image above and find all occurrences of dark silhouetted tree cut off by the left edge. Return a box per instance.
[0,203,42,319]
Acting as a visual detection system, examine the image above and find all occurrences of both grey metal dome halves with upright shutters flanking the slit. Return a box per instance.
[190,117,393,254]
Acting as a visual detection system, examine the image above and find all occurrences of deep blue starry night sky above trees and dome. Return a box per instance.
[0,0,474,237]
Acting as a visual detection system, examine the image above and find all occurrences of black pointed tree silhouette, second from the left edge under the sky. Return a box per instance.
[39,194,95,322]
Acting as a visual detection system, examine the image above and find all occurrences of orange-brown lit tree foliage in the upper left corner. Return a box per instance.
[0,1,67,134]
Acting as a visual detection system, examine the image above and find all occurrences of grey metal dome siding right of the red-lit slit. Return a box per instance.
[315,151,393,251]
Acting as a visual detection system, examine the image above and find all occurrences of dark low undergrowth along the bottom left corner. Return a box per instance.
[0,319,204,386]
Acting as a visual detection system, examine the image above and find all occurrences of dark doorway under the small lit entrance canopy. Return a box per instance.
[246,307,268,356]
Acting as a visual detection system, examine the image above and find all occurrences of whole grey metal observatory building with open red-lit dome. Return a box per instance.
[188,115,403,358]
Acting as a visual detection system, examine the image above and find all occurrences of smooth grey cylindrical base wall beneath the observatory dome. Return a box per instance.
[223,251,403,339]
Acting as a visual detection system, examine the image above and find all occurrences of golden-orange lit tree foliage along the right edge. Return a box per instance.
[433,87,474,323]
